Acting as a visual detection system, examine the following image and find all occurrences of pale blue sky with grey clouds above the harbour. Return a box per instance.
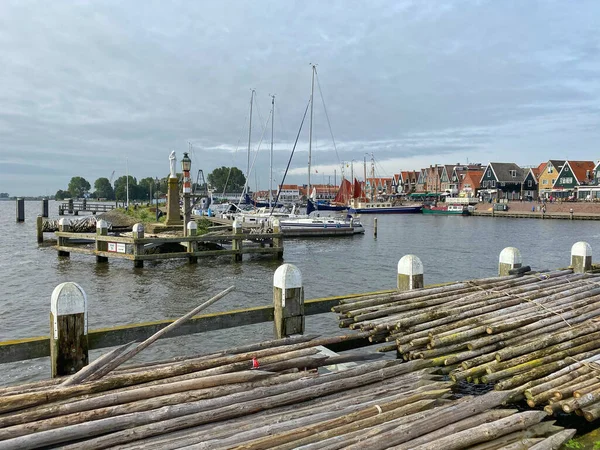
[0,0,600,195]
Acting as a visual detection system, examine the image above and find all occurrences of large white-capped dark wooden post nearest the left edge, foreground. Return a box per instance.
[50,282,88,378]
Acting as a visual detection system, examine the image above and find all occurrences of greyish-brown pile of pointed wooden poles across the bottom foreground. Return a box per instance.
[0,334,574,450]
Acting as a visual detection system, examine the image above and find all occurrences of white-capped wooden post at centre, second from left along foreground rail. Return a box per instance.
[273,264,304,339]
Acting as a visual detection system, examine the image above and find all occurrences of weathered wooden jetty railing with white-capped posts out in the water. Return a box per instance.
[46,218,283,268]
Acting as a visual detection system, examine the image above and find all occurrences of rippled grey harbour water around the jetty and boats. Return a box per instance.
[0,201,600,384]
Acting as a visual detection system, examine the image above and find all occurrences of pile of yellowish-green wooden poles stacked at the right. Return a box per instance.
[334,270,600,420]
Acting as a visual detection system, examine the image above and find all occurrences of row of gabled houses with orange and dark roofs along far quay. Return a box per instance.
[254,160,600,203]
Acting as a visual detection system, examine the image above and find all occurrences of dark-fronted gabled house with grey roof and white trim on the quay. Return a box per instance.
[479,162,525,200]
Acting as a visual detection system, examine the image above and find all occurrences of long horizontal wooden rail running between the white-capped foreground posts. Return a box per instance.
[0,290,394,364]
